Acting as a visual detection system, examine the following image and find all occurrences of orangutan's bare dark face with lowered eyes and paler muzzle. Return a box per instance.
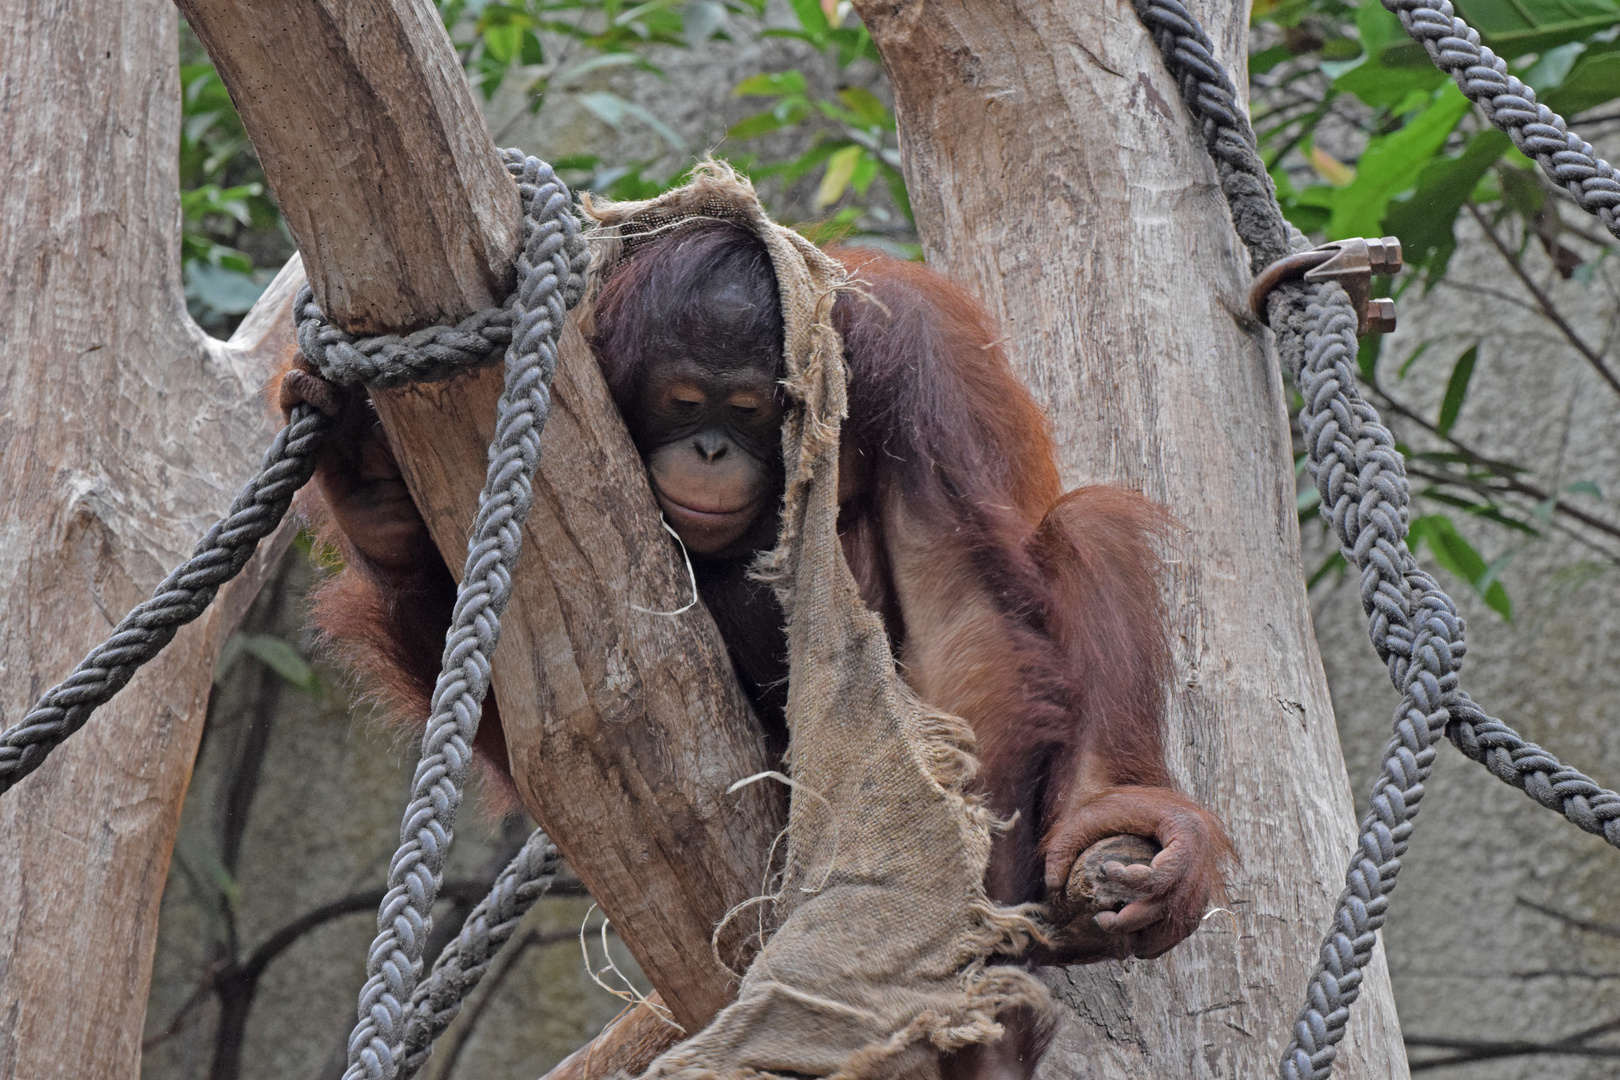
[632,359,782,557]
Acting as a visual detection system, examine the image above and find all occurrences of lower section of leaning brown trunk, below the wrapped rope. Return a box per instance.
[377,335,786,1031]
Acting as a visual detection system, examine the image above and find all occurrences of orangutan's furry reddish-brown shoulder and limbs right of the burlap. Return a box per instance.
[822,251,1230,926]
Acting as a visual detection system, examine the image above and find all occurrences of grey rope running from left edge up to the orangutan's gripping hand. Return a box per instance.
[0,405,332,795]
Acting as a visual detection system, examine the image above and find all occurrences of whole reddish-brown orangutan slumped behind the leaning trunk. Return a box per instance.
[275,220,1230,1077]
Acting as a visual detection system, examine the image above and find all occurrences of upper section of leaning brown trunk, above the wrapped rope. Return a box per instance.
[178,0,520,334]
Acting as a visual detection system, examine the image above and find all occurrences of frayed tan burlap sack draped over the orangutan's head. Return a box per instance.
[586,162,1048,1080]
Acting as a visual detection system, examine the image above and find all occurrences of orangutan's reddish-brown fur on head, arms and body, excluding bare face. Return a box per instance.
[278,223,1230,990]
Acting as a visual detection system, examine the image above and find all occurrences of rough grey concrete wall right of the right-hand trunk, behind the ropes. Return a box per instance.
[1304,213,1620,1080]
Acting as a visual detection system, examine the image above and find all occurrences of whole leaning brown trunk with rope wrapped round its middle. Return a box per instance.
[180,0,784,1030]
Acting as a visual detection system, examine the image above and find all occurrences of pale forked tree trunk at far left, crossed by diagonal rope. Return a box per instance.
[0,0,301,1080]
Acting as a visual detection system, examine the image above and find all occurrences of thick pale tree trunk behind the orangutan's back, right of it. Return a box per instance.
[857,0,1406,1080]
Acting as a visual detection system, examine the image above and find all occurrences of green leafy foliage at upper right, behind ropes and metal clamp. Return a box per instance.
[1249,0,1620,619]
